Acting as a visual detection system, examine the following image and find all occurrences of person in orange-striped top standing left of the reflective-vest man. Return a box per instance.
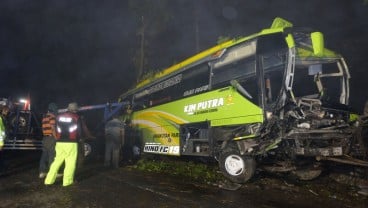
[39,103,58,178]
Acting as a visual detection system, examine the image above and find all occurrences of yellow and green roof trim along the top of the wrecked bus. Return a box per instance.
[120,17,341,98]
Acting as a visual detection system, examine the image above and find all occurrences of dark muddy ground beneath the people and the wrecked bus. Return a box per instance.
[0,152,368,208]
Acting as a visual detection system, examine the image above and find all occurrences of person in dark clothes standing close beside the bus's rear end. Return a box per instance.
[104,117,124,168]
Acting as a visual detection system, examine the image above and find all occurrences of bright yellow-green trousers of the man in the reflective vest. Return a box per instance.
[45,142,78,186]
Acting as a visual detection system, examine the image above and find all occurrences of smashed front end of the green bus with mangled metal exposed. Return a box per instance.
[230,19,362,182]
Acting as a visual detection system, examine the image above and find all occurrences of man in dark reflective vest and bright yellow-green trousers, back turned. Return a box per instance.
[45,103,82,186]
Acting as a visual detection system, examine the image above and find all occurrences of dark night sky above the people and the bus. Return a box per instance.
[0,0,368,114]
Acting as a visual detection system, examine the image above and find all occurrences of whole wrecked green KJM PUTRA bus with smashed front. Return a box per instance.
[119,18,358,183]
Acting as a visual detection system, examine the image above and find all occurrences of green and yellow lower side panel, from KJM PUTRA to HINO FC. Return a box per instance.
[132,87,263,155]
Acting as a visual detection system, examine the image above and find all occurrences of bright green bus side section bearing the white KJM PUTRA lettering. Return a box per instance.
[167,87,263,125]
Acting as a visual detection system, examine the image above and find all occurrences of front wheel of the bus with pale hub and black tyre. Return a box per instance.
[219,148,256,183]
